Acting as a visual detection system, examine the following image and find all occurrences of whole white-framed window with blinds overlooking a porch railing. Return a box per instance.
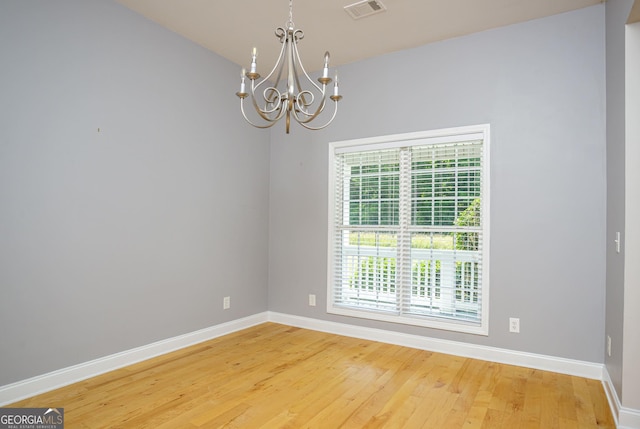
[328,125,489,335]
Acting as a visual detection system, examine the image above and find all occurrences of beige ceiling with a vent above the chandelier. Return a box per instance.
[116,0,604,74]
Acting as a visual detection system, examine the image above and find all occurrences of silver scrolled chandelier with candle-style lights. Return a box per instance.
[236,0,342,134]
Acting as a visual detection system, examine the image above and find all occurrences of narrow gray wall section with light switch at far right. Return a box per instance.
[605,0,633,397]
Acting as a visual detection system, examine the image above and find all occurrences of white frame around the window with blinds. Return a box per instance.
[327,124,490,336]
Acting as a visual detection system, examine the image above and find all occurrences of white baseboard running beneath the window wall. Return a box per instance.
[269,312,604,380]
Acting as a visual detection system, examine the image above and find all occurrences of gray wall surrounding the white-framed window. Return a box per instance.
[269,5,606,362]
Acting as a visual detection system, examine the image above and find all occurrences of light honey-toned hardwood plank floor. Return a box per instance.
[12,323,615,429]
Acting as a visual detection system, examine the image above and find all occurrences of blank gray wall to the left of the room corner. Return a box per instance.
[0,0,269,385]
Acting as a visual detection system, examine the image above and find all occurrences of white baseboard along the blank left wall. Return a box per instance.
[0,312,268,406]
